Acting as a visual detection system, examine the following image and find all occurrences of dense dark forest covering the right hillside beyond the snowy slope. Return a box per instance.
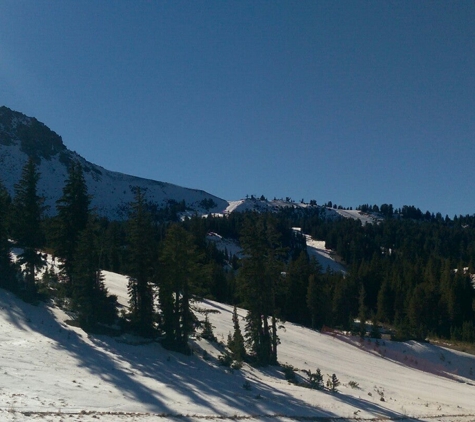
[188,209,475,341]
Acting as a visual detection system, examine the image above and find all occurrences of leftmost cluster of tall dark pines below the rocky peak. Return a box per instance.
[0,159,115,328]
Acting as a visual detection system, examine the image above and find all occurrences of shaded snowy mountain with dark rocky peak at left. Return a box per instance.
[0,107,228,219]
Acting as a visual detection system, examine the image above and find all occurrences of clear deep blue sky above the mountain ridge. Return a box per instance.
[0,0,475,217]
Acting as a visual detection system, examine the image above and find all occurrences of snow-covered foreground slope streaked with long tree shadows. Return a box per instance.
[0,273,475,422]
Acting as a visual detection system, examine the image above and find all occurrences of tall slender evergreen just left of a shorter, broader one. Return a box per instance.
[128,188,155,337]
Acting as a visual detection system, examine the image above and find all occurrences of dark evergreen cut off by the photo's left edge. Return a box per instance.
[0,181,16,291]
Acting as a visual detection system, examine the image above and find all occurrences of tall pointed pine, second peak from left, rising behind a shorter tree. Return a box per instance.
[55,161,90,286]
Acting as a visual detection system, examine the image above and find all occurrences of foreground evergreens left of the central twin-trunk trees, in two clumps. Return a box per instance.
[0,160,218,350]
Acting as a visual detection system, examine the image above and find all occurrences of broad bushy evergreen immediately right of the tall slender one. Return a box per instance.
[157,224,208,353]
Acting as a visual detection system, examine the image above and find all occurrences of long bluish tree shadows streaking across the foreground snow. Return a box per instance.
[0,291,430,421]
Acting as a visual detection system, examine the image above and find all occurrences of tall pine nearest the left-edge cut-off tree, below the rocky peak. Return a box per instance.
[13,158,45,300]
